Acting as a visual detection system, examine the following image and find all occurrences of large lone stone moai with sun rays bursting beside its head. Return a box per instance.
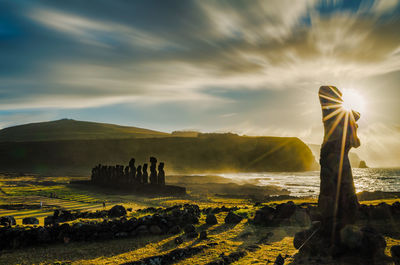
[318,86,360,241]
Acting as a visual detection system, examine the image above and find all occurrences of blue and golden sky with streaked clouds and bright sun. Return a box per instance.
[0,0,400,167]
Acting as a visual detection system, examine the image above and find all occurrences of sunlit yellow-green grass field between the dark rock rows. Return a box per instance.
[0,173,400,265]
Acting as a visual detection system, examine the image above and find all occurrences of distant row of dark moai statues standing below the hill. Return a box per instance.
[92,157,165,185]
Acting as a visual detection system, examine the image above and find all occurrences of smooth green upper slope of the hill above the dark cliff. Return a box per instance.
[0,119,170,142]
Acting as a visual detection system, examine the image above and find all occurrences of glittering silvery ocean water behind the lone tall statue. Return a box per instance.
[217,168,400,196]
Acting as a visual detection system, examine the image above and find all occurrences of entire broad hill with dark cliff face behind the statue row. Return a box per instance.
[0,120,317,175]
